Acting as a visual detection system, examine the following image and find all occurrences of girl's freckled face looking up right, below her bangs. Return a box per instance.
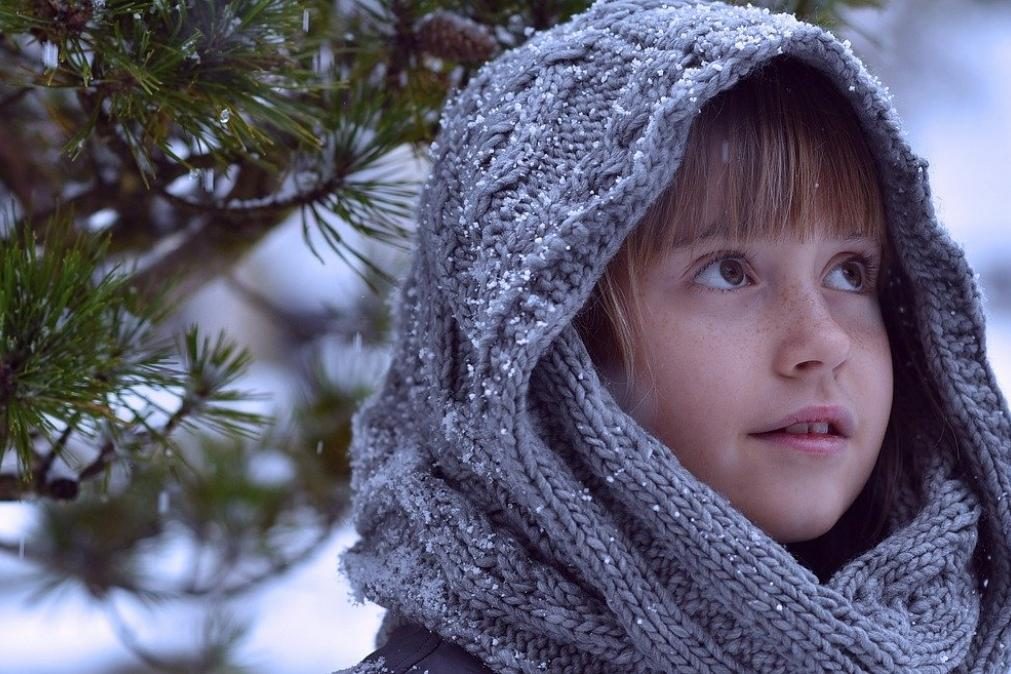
[625,233,892,543]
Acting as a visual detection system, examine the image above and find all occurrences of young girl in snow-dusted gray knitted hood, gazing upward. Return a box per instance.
[344,0,1011,674]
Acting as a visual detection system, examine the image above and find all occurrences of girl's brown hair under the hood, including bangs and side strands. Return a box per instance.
[576,58,901,574]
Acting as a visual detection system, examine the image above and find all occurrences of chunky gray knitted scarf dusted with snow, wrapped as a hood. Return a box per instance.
[343,0,1011,674]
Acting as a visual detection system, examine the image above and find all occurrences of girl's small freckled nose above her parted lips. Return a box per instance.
[771,288,853,377]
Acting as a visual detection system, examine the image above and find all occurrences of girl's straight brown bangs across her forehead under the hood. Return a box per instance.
[629,59,886,263]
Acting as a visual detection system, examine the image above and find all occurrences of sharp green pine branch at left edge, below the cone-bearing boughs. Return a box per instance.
[0,222,266,499]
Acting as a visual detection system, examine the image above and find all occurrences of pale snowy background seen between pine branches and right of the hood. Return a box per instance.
[0,0,1011,674]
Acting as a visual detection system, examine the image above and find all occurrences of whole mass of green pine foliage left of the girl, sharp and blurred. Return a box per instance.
[0,0,878,672]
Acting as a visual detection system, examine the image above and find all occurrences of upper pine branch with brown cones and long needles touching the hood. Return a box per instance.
[0,0,598,309]
